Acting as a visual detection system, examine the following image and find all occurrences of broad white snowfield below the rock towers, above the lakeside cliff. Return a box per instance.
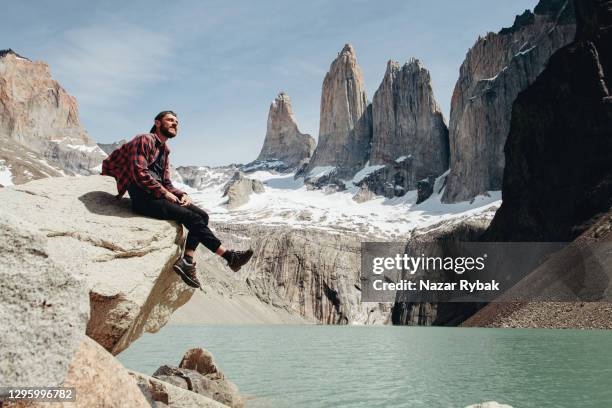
[176,166,501,239]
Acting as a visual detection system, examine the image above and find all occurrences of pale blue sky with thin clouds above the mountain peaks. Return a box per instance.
[7,0,537,165]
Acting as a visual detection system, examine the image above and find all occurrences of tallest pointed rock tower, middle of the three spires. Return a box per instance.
[306,44,372,179]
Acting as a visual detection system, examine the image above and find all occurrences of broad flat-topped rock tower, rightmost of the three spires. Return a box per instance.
[364,59,448,197]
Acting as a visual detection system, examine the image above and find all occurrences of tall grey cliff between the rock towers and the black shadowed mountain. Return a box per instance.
[443,0,575,202]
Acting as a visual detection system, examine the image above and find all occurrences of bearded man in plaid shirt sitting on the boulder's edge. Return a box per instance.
[102,111,253,288]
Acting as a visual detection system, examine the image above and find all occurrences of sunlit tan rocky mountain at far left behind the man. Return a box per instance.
[0,50,106,174]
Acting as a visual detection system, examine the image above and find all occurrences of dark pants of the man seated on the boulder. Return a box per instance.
[128,187,221,252]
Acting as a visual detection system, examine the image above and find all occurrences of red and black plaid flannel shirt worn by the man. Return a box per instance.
[102,133,185,198]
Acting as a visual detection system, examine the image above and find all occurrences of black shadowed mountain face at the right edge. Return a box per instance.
[487,0,612,241]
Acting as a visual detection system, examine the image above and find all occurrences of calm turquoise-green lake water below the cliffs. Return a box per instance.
[119,325,612,408]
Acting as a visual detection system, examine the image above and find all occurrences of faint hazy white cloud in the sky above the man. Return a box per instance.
[50,23,173,107]
